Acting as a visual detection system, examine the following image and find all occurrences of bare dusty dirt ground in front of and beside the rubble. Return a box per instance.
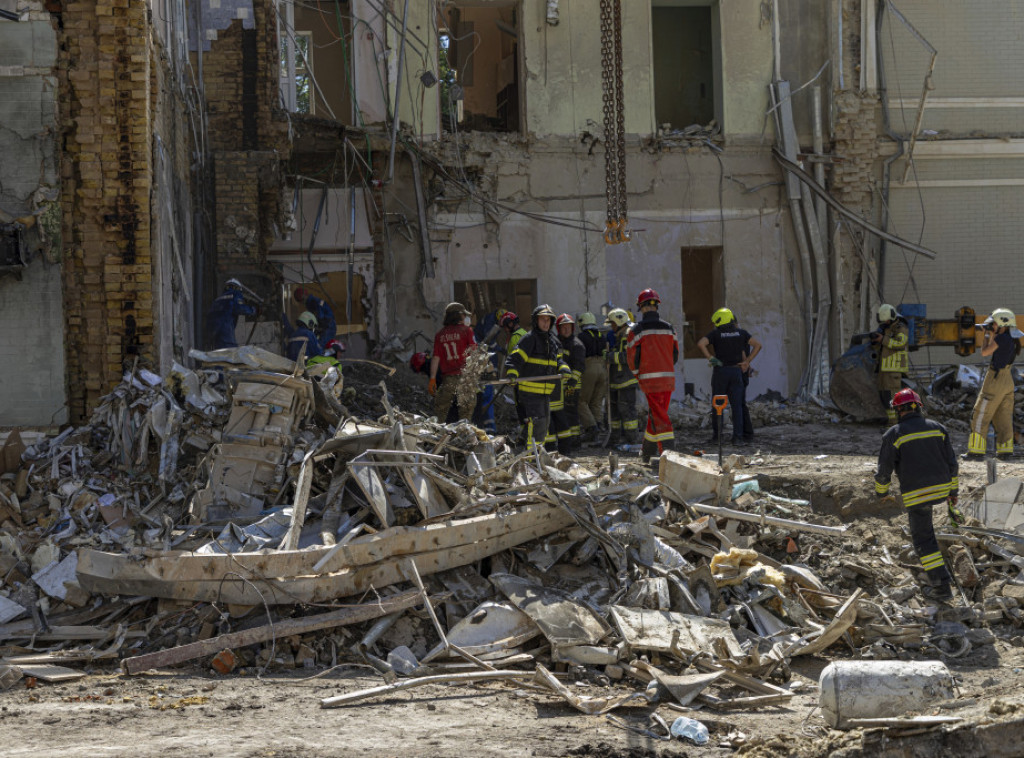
[8,423,1024,758]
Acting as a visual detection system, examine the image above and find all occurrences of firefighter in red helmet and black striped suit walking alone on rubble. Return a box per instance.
[874,389,964,601]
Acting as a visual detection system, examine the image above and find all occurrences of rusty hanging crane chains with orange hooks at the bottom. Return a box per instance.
[601,0,630,245]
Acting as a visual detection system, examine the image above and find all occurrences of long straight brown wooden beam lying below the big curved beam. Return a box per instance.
[121,590,420,674]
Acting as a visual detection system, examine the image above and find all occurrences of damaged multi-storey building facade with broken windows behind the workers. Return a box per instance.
[0,0,1019,425]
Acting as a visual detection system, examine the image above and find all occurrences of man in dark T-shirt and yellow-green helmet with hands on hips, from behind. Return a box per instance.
[697,308,761,447]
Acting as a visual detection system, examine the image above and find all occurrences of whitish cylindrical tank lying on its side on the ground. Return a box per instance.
[818,661,953,729]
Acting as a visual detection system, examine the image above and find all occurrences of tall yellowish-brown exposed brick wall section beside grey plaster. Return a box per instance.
[60,0,153,420]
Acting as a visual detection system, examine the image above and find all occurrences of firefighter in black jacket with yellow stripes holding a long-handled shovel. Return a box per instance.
[505,303,570,447]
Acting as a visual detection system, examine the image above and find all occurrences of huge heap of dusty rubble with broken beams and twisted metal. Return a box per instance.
[0,348,1024,746]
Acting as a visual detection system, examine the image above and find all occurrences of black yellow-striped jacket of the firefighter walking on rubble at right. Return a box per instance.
[874,413,959,508]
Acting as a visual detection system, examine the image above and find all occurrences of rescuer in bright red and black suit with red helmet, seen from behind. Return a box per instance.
[627,289,679,463]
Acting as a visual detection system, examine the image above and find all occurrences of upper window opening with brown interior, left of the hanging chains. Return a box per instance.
[438,0,522,131]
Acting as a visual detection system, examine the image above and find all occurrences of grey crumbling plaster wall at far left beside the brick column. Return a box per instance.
[0,7,68,426]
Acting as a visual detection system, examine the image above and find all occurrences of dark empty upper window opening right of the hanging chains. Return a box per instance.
[651,0,722,129]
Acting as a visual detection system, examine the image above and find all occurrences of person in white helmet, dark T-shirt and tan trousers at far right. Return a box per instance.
[964,308,1024,460]
